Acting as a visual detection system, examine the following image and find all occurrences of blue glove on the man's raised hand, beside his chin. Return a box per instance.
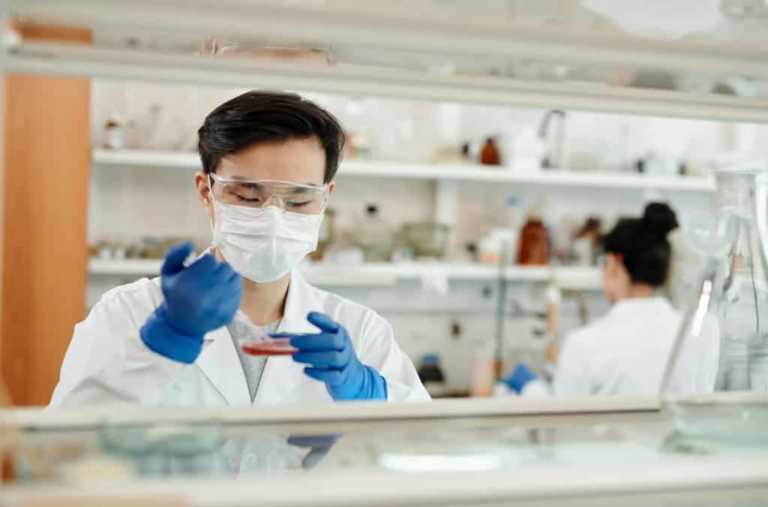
[140,243,243,363]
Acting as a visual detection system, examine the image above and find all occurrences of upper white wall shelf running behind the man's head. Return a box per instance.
[93,150,715,193]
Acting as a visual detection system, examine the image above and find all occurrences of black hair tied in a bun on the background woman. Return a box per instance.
[603,202,678,287]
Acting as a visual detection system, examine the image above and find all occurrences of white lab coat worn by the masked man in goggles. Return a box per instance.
[51,271,429,406]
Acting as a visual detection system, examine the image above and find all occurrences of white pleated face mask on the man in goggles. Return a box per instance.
[213,200,323,283]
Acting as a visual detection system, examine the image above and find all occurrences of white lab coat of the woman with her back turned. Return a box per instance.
[522,297,719,396]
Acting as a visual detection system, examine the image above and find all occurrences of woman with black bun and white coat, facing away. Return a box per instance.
[504,203,714,396]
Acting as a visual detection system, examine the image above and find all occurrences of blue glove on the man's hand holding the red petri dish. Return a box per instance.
[272,312,387,401]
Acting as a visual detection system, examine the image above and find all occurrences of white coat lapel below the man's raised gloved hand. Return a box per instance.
[196,327,251,405]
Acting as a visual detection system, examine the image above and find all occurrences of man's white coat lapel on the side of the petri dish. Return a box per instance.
[255,270,331,404]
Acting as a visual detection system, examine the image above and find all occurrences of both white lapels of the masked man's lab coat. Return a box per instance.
[197,270,322,405]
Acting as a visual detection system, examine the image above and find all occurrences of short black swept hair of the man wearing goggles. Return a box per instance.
[197,91,344,183]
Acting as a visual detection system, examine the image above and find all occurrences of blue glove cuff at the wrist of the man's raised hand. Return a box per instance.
[139,304,203,364]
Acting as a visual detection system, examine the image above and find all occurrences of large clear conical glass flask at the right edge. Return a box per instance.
[662,168,768,444]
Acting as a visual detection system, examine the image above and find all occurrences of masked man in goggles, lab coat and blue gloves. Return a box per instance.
[51,92,429,406]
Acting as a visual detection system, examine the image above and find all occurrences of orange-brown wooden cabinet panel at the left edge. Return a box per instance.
[0,25,91,405]
